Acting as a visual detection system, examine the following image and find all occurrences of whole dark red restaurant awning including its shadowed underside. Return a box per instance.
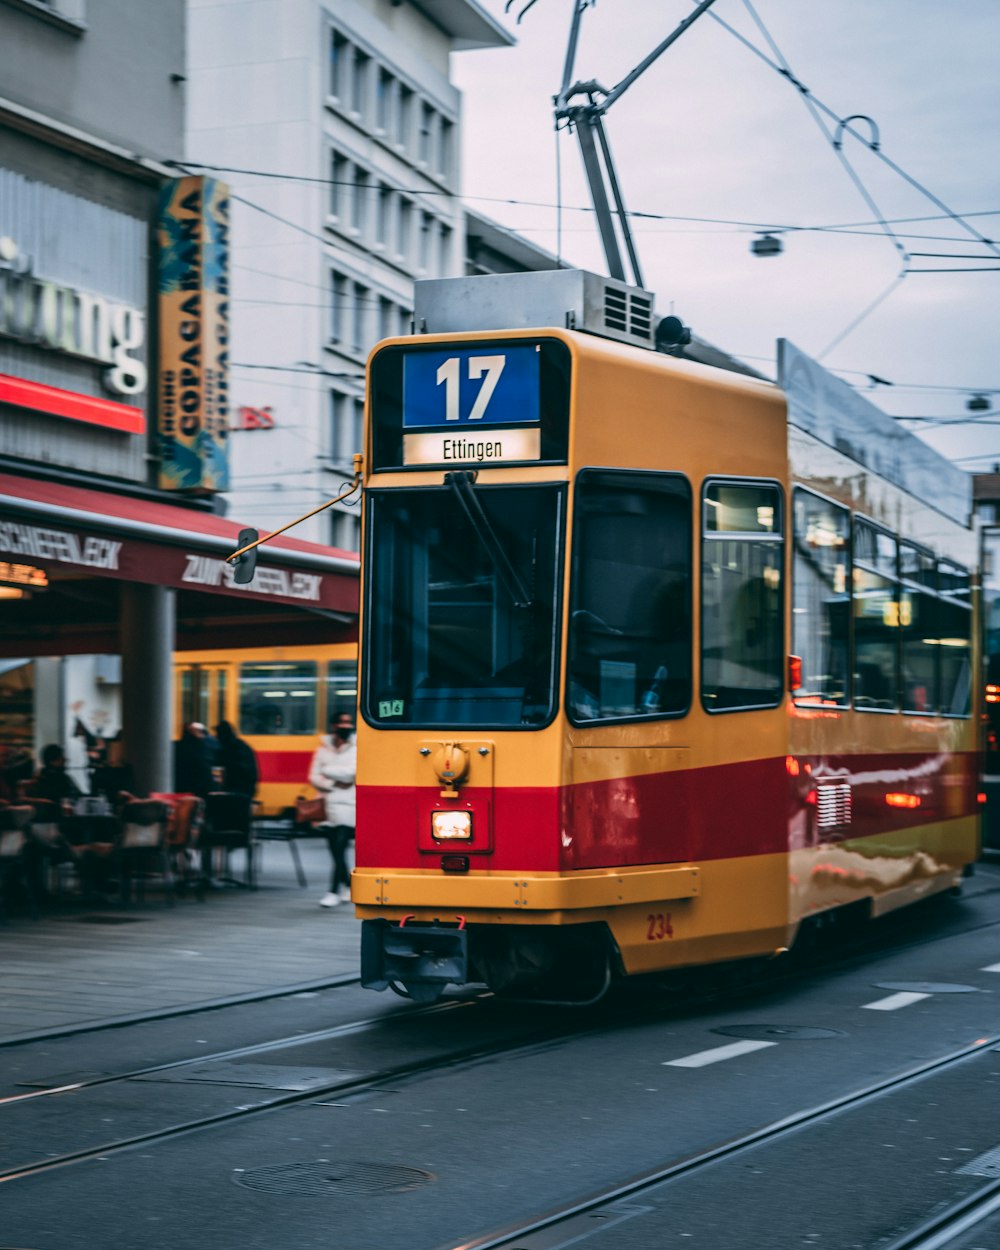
[0,474,359,655]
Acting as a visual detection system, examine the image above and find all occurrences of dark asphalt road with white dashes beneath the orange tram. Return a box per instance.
[0,866,1000,1250]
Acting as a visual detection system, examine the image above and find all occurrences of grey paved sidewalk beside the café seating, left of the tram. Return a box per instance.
[0,840,360,1041]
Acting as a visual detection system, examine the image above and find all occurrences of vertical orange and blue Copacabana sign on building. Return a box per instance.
[159,176,229,494]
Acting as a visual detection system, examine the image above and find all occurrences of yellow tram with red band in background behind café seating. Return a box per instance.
[174,643,358,816]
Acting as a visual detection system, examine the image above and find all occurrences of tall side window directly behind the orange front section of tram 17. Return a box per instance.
[791,488,851,708]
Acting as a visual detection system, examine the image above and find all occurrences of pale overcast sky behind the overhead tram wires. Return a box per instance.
[453,0,1000,468]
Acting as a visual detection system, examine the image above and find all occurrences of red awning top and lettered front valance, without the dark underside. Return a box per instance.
[0,474,359,615]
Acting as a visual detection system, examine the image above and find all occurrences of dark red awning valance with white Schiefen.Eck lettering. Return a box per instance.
[0,518,358,611]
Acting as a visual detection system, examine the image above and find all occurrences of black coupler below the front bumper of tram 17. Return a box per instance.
[361,916,469,999]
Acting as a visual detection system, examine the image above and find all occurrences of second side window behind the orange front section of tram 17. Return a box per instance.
[854,520,900,711]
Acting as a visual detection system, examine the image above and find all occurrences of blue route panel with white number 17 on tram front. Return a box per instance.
[403,343,540,430]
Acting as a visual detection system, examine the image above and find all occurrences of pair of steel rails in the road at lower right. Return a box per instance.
[447,1035,1000,1250]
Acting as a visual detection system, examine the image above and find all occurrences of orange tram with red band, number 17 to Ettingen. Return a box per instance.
[353,271,979,1000]
